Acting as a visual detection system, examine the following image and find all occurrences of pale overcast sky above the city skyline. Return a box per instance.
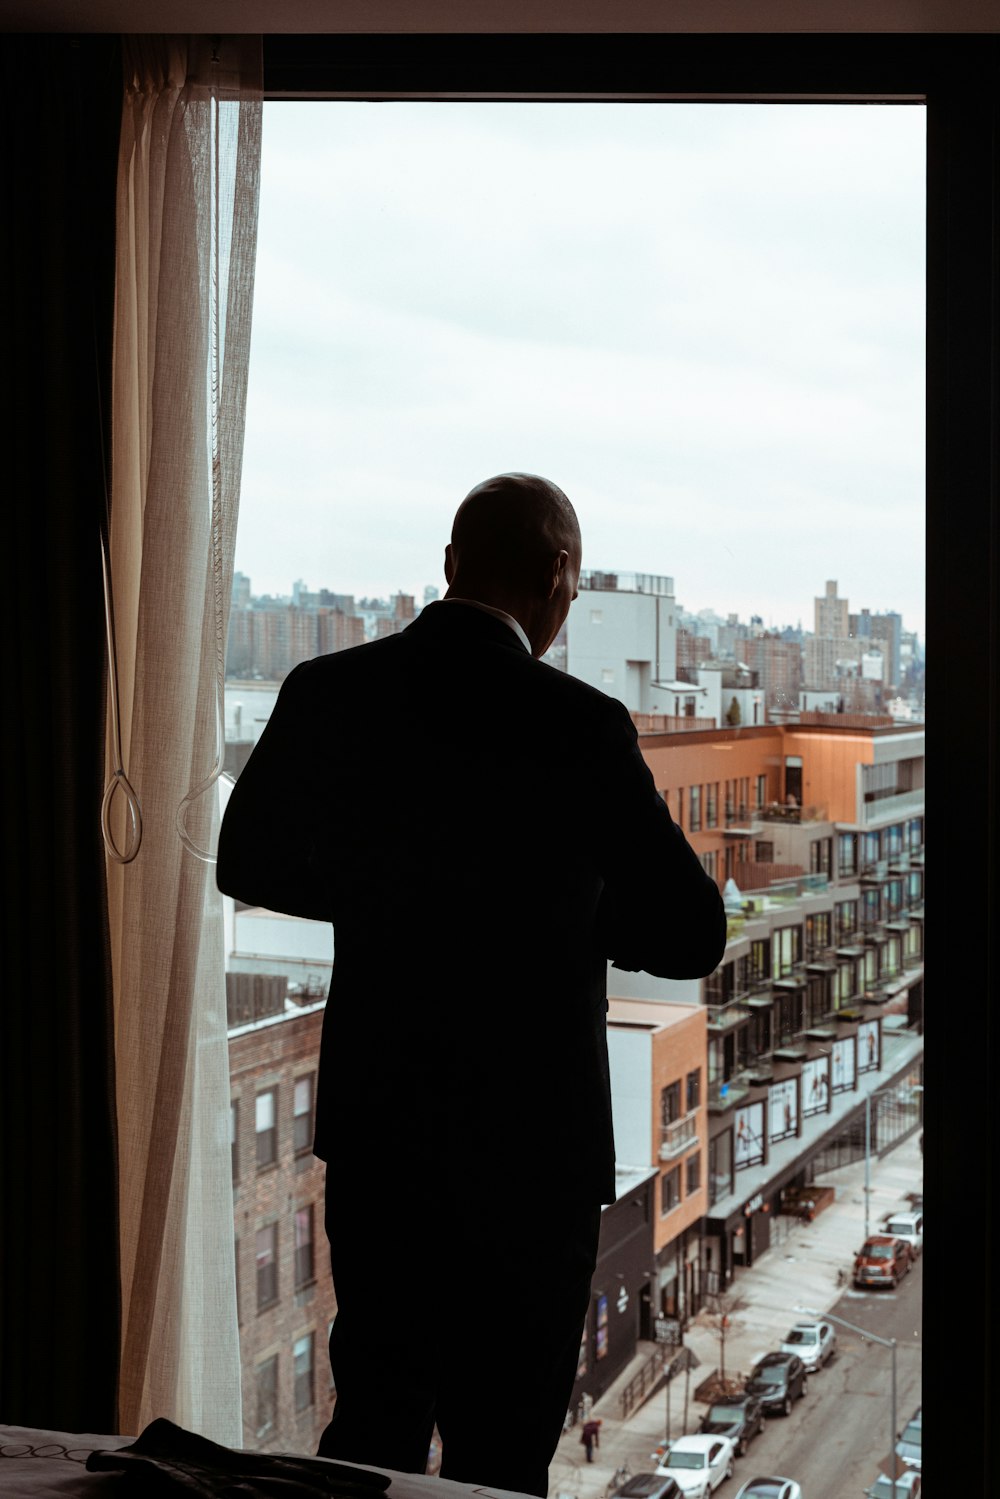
[237,102,924,636]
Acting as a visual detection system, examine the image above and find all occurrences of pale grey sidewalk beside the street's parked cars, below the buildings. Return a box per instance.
[549,1130,924,1499]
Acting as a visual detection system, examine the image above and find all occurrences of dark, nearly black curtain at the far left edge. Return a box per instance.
[0,34,121,1432]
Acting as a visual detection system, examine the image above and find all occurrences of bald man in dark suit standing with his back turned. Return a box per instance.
[217,474,726,1495]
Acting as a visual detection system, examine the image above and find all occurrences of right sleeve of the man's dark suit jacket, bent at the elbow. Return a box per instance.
[595,703,726,979]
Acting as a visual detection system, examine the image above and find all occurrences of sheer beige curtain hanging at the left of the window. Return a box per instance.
[108,36,262,1445]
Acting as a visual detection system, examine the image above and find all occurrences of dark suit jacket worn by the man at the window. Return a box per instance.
[217,603,726,1202]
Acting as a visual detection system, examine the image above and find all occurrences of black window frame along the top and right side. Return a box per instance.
[262,35,1000,1492]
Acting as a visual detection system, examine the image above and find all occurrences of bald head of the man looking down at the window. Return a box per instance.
[445,474,580,655]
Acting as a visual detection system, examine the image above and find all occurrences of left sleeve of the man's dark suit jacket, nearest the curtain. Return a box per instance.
[216,661,333,922]
